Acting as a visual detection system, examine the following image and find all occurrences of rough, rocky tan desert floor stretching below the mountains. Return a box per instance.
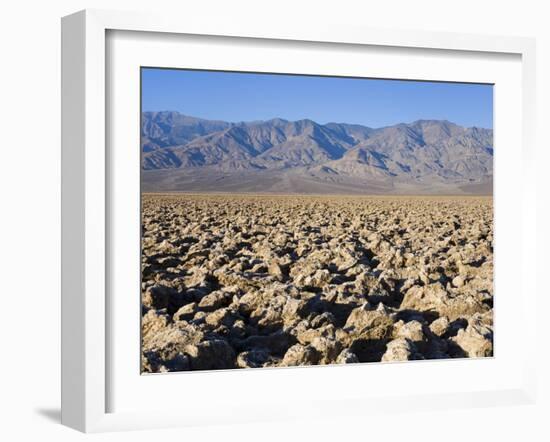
[142,194,493,372]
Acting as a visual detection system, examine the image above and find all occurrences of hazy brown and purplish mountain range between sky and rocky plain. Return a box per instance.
[141,111,493,194]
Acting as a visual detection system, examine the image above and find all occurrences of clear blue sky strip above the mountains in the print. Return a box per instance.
[141,68,493,128]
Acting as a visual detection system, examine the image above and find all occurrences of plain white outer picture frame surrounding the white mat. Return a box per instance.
[62,10,536,432]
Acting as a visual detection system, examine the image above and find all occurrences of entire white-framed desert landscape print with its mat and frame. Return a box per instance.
[62,11,536,432]
